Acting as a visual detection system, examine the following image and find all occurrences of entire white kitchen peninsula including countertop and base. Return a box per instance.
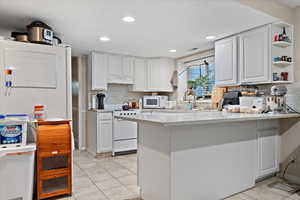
[117,111,300,200]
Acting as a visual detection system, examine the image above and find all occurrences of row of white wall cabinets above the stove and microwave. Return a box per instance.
[89,52,175,92]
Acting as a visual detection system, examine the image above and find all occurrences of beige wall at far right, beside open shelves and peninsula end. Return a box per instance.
[238,0,300,181]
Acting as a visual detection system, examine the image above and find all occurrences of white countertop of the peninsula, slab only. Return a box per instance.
[116,111,300,126]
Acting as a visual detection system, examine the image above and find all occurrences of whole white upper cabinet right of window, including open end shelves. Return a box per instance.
[215,22,294,86]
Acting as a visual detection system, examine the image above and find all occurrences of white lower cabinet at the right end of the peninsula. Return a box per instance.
[257,120,280,178]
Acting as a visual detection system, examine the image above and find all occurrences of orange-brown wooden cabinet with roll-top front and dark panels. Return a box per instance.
[37,121,72,200]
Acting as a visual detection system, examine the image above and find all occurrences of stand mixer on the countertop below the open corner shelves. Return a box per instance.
[267,85,287,113]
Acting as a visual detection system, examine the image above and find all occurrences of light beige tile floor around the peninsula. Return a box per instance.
[54,151,300,200]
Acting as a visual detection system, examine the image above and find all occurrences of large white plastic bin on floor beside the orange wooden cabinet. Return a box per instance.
[0,144,36,200]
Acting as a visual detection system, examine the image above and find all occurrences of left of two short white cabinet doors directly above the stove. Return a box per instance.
[107,54,123,83]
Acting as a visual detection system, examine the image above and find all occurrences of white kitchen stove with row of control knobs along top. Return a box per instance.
[113,110,139,156]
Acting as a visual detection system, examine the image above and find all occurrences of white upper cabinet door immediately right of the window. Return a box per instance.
[215,37,238,86]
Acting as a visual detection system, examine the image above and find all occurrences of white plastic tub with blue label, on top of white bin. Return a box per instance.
[0,115,29,148]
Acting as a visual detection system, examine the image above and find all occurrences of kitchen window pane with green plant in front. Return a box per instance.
[187,61,215,98]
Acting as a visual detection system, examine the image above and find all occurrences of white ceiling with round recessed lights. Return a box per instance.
[0,0,275,57]
